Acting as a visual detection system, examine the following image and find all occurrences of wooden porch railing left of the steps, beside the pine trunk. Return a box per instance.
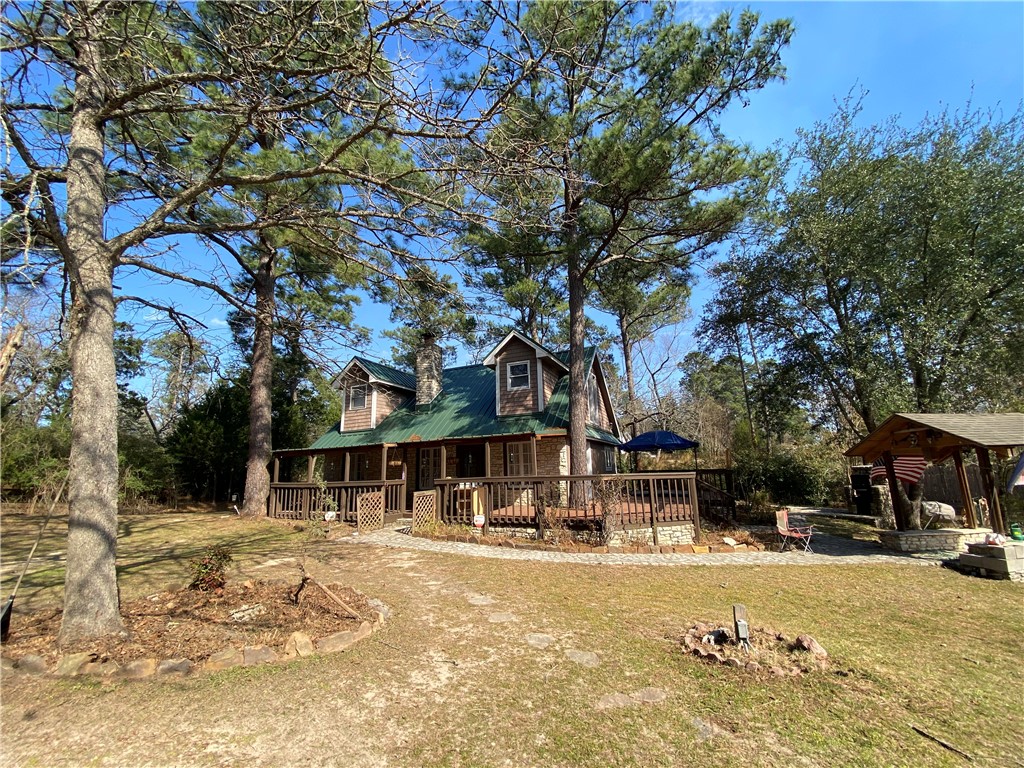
[267,480,406,522]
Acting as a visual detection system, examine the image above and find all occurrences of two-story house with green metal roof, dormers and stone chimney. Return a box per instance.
[270,332,621,514]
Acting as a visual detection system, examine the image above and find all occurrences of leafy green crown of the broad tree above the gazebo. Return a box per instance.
[705,93,1024,434]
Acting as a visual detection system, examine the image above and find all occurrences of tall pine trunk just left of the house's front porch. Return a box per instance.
[242,239,276,517]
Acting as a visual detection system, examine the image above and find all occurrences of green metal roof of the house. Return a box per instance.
[309,358,621,451]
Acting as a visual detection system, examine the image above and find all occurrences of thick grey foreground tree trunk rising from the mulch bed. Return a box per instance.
[59,3,124,644]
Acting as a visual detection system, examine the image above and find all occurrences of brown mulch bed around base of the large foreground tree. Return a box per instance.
[3,581,374,665]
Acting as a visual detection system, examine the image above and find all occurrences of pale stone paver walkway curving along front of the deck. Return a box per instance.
[338,527,951,565]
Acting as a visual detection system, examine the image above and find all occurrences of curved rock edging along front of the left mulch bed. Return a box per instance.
[3,590,391,680]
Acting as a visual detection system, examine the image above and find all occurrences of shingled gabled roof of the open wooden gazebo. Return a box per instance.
[846,414,1024,464]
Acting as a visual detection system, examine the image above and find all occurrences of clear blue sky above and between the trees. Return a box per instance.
[116,2,1024,366]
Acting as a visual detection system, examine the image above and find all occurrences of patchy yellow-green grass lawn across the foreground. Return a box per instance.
[2,505,1024,766]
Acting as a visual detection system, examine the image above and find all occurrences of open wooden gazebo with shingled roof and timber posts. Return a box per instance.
[846,414,1024,534]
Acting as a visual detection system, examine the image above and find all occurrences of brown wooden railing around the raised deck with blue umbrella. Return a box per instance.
[435,472,699,530]
